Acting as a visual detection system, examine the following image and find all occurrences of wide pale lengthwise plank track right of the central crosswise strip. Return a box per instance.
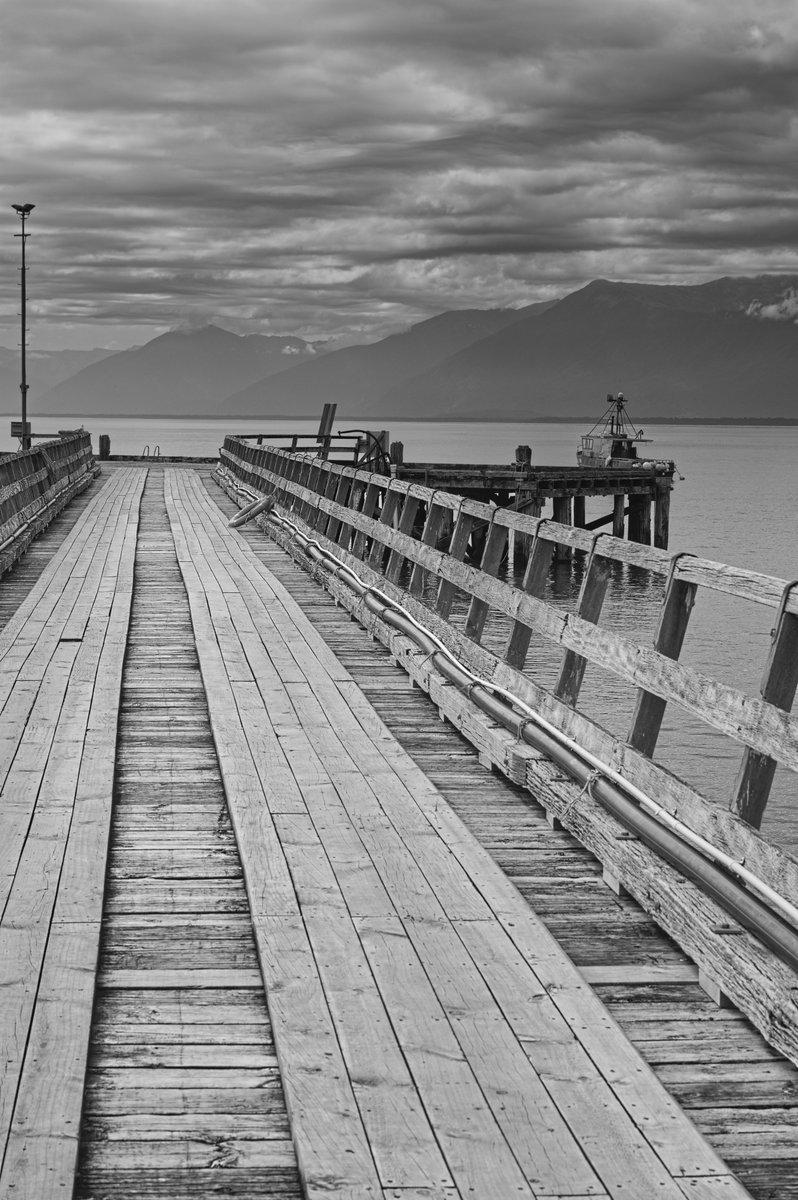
[167,472,744,1198]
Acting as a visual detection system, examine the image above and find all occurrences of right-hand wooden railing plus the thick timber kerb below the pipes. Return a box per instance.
[221,438,798,1058]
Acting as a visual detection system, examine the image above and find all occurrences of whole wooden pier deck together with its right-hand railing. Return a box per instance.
[0,439,798,1200]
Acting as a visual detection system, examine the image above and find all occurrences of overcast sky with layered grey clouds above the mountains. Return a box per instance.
[0,0,798,348]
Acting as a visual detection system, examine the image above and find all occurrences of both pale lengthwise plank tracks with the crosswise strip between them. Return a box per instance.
[0,460,792,1200]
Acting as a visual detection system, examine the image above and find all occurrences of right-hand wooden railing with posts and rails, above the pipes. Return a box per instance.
[222,438,798,849]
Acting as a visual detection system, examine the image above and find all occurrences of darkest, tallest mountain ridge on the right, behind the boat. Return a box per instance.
[374,276,798,420]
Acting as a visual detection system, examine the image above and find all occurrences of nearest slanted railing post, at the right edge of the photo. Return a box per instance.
[731,611,798,829]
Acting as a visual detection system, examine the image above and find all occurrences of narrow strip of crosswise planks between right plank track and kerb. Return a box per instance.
[230,488,798,1200]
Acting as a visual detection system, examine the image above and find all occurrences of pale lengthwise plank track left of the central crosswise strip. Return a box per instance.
[0,469,146,1198]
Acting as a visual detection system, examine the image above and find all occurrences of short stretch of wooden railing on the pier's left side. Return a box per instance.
[0,430,98,575]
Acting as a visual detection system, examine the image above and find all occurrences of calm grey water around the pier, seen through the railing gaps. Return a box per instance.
[7,416,798,852]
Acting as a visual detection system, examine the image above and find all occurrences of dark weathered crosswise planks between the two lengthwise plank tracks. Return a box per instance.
[74,470,300,1200]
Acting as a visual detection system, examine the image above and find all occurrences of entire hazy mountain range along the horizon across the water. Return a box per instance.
[10,275,798,424]
